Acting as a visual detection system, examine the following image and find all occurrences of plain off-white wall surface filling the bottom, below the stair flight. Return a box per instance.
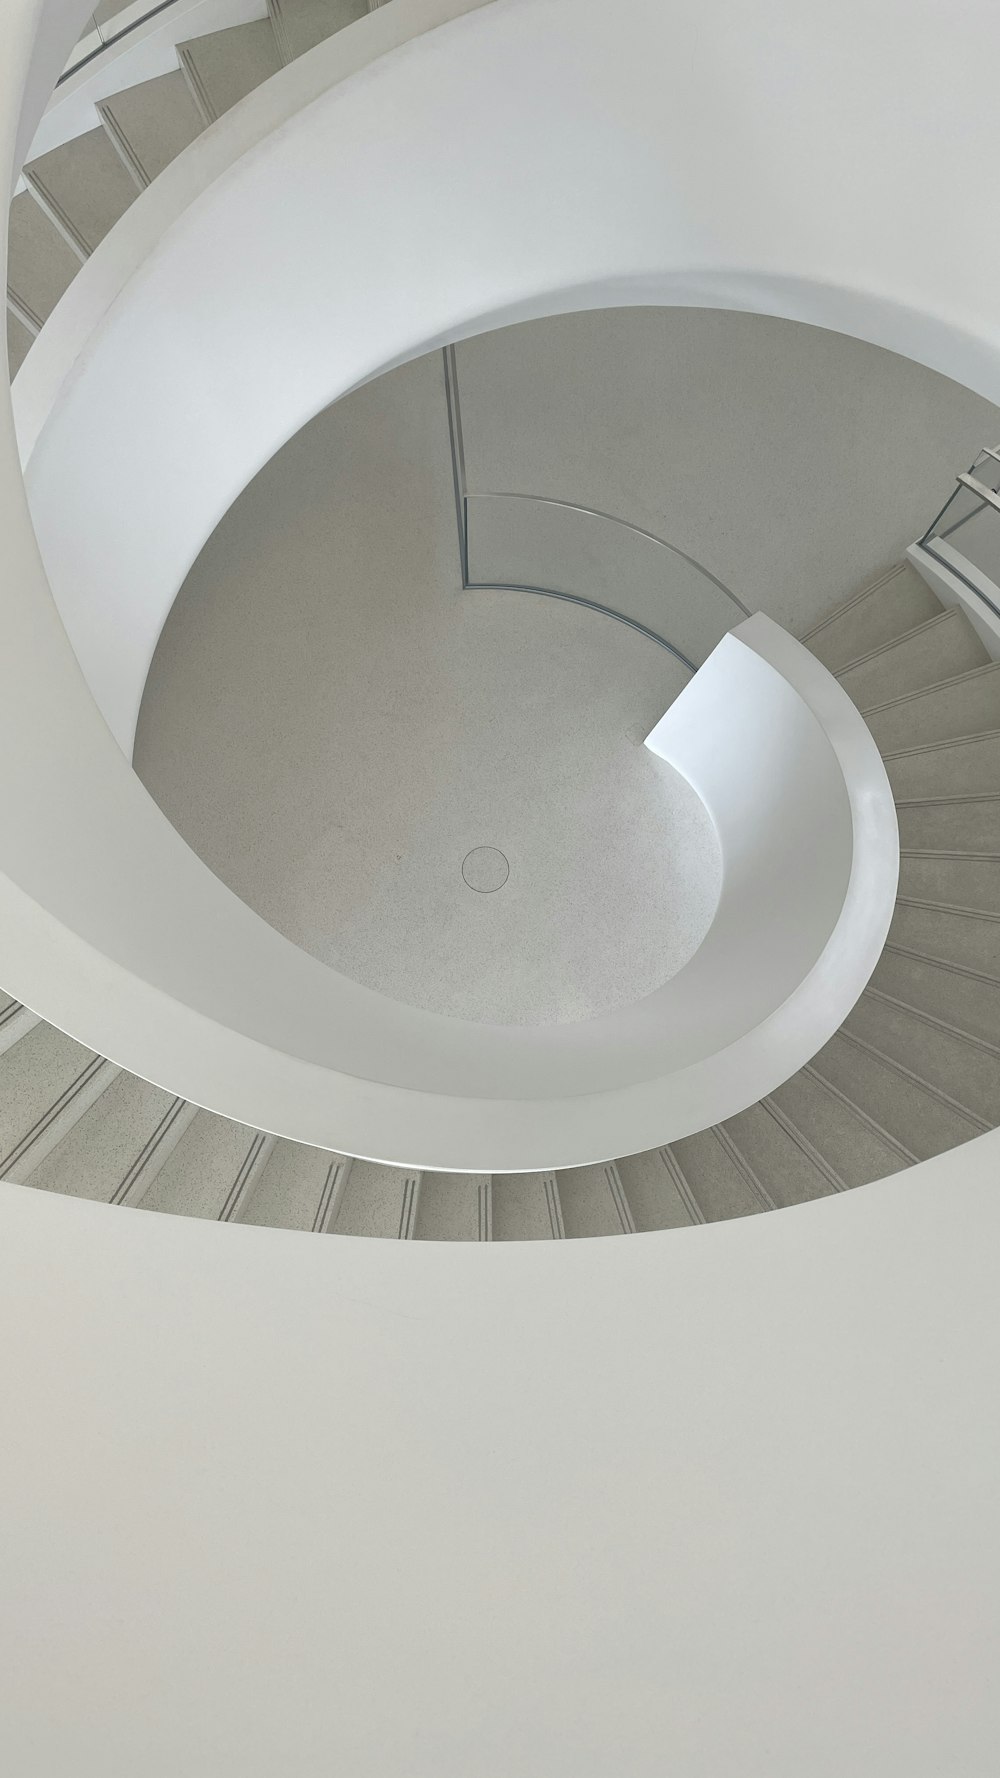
[0,1138,1000,1778]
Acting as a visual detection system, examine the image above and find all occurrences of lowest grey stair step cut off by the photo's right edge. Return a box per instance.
[843,990,1000,1116]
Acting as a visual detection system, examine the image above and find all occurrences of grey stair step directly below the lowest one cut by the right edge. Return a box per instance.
[810,1033,982,1161]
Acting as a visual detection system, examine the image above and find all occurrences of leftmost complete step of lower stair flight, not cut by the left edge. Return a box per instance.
[28,1070,178,1204]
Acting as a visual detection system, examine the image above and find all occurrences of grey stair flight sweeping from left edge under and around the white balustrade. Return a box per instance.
[0,565,1000,1241]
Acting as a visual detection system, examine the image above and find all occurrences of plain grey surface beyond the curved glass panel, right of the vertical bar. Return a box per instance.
[457,308,1000,633]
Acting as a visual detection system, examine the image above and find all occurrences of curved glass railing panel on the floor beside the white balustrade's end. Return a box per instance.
[466,494,749,667]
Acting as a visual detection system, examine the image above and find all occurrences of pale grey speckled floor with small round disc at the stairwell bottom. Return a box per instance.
[135,344,721,1022]
